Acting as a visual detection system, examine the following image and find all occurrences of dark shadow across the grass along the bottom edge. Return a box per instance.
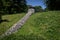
[0,35,45,40]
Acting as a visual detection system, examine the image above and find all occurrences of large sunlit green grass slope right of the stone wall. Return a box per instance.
[2,11,60,40]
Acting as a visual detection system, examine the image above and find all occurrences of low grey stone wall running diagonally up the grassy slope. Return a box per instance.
[0,10,34,38]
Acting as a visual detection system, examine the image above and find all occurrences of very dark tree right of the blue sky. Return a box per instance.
[46,0,60,10]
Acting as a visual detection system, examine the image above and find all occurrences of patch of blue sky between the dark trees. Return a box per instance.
[26,0,46,9]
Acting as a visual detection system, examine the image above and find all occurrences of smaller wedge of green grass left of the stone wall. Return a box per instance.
[0,13,25,35]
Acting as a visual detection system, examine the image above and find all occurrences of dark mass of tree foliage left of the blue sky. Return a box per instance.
[0,0,27,22]
